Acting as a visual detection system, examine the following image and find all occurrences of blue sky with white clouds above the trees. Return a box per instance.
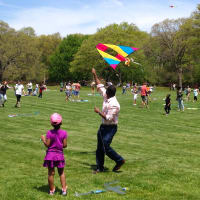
[0,0,200,36]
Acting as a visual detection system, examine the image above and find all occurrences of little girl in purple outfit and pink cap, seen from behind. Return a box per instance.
[41,113,68,195]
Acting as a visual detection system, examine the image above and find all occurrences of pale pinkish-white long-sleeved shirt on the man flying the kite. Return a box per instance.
[97,84,120,125]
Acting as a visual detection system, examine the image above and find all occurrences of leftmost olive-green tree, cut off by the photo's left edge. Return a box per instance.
[0,22,40,80]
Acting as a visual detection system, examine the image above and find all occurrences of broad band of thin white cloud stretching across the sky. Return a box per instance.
[7,0,198,36]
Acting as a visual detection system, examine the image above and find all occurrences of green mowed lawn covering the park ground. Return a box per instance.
[0,87,200,200]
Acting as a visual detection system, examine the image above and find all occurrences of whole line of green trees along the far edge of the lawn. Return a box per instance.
[0,4,200,86]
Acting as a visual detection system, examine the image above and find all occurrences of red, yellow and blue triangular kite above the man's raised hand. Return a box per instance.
[96,43,138,69]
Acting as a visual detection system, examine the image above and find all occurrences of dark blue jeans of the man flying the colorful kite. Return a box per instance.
[96,125,124,170]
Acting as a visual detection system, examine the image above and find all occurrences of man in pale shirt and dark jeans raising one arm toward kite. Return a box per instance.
[92,68,125,173]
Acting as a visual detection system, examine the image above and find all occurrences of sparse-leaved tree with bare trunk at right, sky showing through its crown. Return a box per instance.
[146,19,192,87]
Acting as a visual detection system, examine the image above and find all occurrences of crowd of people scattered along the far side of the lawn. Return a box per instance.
[0,81,199,111]
